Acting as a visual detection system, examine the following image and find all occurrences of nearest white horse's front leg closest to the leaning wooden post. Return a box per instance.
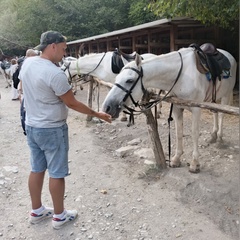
[170,105,183,167]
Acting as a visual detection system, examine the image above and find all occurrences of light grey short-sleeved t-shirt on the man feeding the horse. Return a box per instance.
[19,56,71,128]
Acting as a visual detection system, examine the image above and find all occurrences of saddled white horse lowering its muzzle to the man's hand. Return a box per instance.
[102,47,237,173]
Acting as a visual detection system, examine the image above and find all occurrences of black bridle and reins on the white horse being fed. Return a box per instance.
[115,52,183,124]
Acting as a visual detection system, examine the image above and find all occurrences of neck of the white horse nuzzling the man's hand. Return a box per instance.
[142,52,185,91]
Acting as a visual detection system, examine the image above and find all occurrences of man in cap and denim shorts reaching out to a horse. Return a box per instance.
[19,31,111,229]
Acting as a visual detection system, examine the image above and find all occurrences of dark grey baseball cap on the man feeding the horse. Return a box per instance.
[34,31,66,51]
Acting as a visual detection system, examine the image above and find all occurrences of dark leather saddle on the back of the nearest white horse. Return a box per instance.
[189,43,231,102]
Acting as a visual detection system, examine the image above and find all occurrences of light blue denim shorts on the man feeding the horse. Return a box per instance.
[26,124,69,178]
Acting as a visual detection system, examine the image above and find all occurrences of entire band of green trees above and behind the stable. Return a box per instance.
[0,0,239,54]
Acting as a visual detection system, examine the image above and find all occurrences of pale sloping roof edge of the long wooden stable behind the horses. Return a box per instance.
[67,17,192,45]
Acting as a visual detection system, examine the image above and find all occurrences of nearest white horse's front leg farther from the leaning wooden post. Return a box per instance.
[189,108,201,173]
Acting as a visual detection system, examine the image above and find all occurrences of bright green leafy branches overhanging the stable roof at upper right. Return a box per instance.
[149,0,239,28]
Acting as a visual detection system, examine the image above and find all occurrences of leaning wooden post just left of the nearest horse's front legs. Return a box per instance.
[142,92,167,169]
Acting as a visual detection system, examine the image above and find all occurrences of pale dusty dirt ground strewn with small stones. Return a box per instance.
[0,76,239,240]
